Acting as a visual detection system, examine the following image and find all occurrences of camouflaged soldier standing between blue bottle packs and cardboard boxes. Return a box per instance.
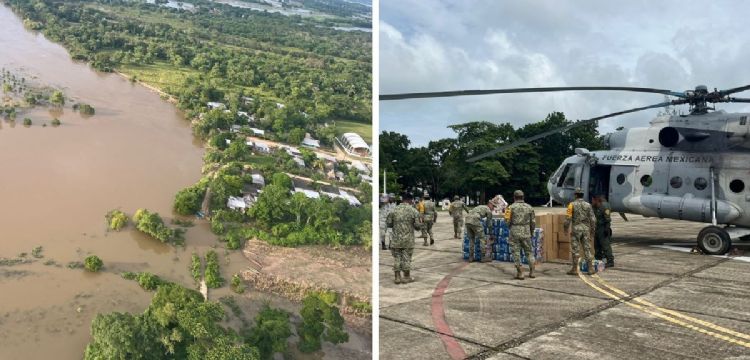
[505,190,536,280]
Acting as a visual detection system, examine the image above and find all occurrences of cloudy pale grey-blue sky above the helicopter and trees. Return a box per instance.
[379,0,750,146]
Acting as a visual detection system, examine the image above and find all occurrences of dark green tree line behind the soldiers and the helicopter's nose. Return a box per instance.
[380,112,604,203]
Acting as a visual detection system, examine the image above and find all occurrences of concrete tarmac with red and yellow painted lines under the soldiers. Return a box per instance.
[380,209,750,360]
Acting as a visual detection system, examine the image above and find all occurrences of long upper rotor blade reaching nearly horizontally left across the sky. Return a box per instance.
[379,86,688,100]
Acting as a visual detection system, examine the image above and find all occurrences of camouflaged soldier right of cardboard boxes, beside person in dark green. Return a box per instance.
[565,188,596,275]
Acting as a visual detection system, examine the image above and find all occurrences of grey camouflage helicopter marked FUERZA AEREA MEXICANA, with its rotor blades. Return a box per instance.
[380,85,750,255]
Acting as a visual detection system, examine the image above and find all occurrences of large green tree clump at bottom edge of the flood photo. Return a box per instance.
[85,284,259,360]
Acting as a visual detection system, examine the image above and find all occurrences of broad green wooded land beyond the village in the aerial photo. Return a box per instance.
[8,0,372,144]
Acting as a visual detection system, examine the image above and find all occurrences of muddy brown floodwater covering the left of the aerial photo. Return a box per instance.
[0,5,370,359]
